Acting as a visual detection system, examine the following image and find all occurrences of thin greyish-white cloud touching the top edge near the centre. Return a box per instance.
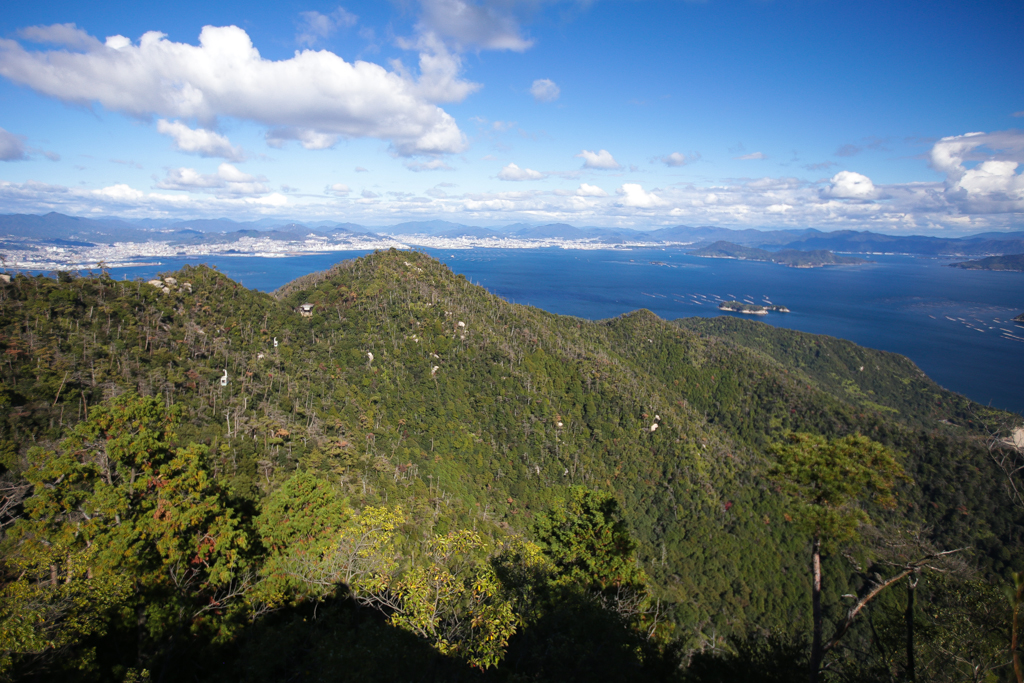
[420,0,534,52]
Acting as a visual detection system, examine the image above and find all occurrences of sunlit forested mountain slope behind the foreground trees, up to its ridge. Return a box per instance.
[0,252,1024,631]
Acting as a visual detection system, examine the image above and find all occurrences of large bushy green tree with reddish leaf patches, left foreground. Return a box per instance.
[7,394,252,671]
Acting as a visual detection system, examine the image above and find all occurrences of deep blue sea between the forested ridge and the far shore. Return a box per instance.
[112,249,1024,414]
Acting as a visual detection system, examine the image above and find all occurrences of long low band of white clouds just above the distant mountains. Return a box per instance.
[0,168,1019,234]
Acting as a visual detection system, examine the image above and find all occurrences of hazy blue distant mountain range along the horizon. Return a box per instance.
[0,213,1024,256]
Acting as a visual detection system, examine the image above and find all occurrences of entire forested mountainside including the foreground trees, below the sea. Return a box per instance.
[0,250,1024,682]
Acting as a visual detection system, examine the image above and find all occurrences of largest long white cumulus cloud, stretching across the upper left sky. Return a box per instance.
[0,25,468,156]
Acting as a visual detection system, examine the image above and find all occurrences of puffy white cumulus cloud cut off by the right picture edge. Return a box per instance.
[930,130,1024,213]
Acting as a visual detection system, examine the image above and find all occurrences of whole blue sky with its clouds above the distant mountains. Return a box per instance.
[0,0,1024,234]
